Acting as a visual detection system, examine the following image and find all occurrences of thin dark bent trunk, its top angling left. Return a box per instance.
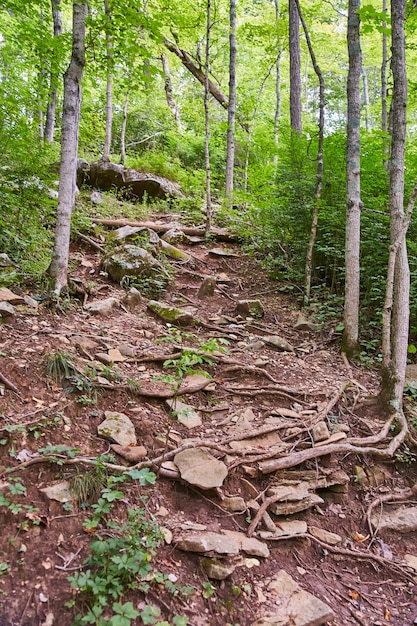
[296,0,326,306]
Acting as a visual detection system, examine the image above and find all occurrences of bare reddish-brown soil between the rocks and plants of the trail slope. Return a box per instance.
[0,229,417,626]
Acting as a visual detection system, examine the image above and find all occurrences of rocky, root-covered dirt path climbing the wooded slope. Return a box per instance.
[0,222,417,626]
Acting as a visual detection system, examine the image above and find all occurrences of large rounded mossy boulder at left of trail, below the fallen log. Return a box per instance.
[102,244,169,283]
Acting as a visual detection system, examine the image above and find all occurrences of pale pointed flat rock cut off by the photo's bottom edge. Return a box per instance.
[253,570,335,626]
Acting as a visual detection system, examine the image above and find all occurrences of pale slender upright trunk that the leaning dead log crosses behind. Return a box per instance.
[225,0,237,201]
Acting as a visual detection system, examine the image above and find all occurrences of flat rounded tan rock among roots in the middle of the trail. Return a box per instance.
[174,448,228,489]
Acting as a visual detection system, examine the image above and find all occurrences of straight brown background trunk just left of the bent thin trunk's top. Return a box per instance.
[288,0,303,133]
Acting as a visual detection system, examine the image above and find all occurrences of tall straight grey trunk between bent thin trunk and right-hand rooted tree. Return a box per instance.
[342,0,362,356]
